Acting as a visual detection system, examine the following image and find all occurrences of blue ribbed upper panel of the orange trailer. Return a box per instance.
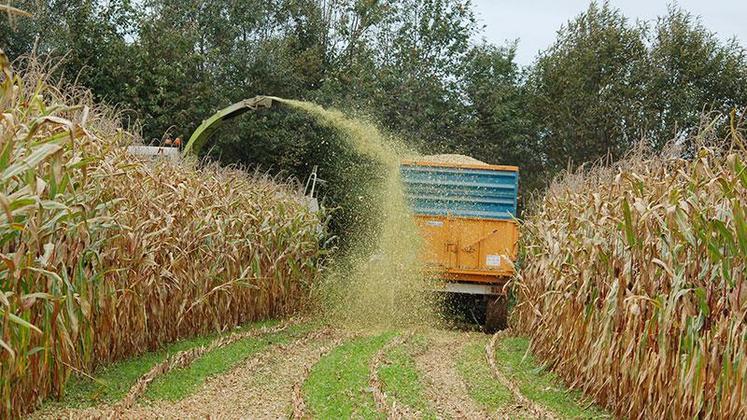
[400,164,519,220]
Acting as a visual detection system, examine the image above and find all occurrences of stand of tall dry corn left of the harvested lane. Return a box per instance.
[0,55,321,418]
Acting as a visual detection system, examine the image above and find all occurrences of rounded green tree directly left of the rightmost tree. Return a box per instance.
[529,1,646,170]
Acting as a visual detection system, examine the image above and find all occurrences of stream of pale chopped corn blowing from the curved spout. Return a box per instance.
[273,98,438,327]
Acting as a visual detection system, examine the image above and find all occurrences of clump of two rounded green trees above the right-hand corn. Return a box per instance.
[527,1,747,174]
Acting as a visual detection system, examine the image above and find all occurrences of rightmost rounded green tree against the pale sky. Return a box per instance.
[646,7,747,147]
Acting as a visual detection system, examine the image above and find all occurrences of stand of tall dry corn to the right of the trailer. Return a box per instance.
[513,133,747,418]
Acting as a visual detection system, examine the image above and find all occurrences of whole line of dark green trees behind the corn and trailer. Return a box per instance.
[0,0,747,207]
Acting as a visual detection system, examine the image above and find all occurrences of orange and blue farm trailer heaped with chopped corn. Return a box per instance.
[400,158,519,330]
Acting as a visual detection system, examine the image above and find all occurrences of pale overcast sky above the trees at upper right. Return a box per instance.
[473,0,747,65]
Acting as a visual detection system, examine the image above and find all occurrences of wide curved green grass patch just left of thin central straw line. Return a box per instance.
[303,333,395,419]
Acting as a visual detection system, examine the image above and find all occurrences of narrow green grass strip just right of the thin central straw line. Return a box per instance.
[378,336,436,419]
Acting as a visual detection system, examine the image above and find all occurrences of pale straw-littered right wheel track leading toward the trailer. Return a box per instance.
[415,331,489,419]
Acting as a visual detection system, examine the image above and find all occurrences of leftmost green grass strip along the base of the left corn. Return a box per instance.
[49,321,277,408]
